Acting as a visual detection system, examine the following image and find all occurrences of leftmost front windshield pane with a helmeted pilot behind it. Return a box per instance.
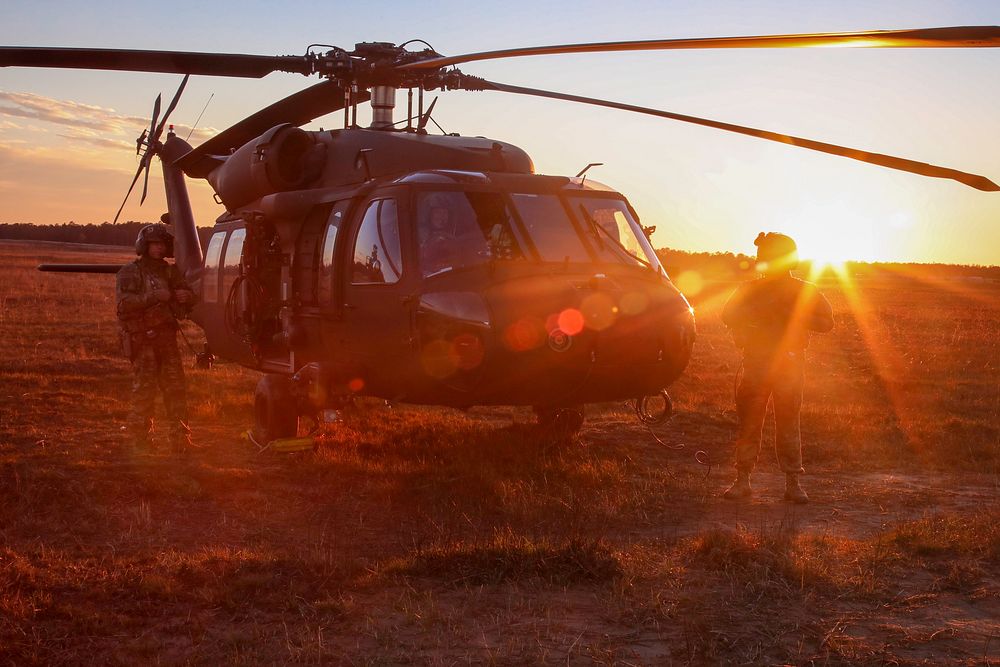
[416,191,524,278]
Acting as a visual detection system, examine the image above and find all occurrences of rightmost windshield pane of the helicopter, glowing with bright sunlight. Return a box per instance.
[569,197,659,269]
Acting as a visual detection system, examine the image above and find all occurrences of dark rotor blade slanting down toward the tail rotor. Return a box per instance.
[176,80,371,178]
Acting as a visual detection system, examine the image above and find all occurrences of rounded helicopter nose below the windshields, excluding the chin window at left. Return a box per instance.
[489,274,695,404]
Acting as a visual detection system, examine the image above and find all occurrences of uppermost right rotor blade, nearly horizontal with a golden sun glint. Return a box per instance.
[396,26,1000,70]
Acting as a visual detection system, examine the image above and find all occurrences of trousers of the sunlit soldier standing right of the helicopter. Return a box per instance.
[736,352,805,473]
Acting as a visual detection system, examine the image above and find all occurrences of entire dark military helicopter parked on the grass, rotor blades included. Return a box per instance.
[0,26,1000,443]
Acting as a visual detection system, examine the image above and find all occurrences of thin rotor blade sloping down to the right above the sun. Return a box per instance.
[481,81,1000,192]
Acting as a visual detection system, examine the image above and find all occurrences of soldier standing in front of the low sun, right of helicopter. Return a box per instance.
[722,232,833,503]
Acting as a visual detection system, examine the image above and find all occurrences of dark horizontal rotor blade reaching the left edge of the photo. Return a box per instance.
[0,46,312,79]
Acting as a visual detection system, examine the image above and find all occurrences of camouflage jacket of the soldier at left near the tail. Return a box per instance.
[115,257,192,333]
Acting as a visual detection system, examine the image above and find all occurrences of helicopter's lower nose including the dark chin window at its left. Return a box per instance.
[416,276,695,405]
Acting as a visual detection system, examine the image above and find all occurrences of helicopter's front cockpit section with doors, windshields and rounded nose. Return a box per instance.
[321,170,694,405]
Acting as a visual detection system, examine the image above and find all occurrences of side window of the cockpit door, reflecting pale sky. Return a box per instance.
[351,199,402,285]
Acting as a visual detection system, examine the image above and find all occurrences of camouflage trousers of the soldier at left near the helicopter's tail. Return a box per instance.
[129,329,190,443]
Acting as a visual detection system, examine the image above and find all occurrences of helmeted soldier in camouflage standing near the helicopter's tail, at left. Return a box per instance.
[115,222,195,451]
